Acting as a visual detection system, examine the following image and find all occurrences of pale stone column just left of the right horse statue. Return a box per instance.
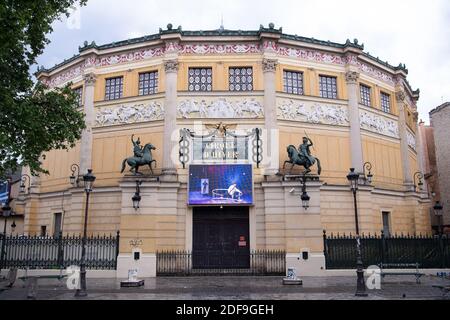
[262,58,279,175]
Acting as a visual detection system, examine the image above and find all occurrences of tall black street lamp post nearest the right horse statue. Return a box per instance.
[347,168,367,297]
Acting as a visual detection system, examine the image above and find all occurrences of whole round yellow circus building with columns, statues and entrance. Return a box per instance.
[15,24,431,276]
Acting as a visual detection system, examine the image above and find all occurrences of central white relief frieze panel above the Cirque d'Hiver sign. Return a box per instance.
[177,98,264,119]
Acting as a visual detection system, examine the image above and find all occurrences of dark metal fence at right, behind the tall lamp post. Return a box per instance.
[323,231,450,269]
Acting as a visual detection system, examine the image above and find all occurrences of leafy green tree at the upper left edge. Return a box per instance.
[0,0,87,177]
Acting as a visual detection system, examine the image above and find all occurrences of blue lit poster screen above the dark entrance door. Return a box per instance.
[188,164,253,206]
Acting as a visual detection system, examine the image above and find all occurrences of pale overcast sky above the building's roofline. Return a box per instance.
[38,0,450,122]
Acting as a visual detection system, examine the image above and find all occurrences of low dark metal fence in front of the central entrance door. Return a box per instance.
[156,250,286,276]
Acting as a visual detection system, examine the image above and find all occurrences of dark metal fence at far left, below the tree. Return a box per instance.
[0,232,120,270]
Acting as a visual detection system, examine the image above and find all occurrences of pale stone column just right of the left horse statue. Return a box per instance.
[161,59,178,180]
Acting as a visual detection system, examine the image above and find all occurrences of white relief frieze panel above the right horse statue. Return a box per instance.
[277,99,349,126]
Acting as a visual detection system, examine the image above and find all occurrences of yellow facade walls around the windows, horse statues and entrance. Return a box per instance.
[17,26,431,278]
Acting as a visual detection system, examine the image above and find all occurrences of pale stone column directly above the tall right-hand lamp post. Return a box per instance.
[345,71,364,173]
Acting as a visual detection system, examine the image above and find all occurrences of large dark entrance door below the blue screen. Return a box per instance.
[192,207,250,269]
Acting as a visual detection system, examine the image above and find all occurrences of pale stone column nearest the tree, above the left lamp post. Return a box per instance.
[80,73,96,175]
